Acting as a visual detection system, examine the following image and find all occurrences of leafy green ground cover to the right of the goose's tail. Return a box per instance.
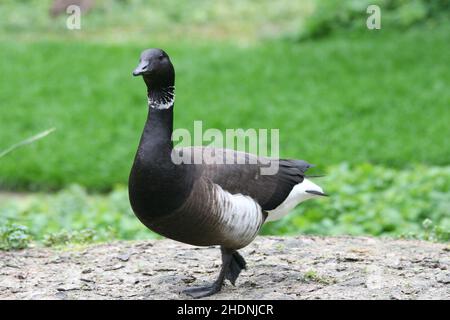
[263,163,450,241]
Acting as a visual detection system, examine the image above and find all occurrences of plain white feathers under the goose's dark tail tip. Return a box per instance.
[266,178,323,221]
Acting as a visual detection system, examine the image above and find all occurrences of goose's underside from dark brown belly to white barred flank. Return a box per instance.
[145,182,265,249]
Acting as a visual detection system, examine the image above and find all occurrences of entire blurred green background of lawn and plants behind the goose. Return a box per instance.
[0,0,450,249]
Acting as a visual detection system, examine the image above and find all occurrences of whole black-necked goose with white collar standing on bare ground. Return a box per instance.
[128,48,326,298]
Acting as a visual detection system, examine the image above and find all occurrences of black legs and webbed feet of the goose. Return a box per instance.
[183,247,246,299]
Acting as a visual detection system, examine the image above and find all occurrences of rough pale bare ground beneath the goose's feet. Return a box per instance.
[0,236,450,299]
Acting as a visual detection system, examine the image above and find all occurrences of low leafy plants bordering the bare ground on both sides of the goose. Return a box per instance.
[0,164,450,249]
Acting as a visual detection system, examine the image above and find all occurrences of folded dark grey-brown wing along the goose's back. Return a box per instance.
[175,147,312,211]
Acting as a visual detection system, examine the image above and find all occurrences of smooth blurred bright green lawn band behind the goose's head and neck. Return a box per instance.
[0,24,450,191]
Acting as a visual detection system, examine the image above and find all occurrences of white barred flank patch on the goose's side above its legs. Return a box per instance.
[215,185,264,248]
